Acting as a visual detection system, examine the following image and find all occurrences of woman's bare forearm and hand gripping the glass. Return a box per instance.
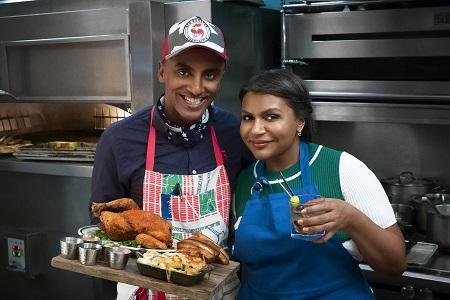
[297,198,406,275]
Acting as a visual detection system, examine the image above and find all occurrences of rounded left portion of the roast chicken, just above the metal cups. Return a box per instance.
[100,211,137,241]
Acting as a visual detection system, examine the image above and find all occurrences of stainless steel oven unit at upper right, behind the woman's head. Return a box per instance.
[283,0,450,104]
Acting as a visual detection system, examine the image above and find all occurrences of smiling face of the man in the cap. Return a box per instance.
[158,48,225,126]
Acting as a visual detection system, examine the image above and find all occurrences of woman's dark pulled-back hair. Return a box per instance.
[239,69,315,141]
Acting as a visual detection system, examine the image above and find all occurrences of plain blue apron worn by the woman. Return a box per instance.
[233,143,374,300]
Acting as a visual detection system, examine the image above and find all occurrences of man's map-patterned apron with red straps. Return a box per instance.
[119,108,231,300]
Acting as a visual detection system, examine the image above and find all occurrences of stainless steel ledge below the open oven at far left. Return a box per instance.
[0,156,93,178]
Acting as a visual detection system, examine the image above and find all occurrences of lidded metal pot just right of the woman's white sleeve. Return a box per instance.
[381,172,439,204]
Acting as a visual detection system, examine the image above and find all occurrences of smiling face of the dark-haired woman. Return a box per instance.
[241,92,305,171]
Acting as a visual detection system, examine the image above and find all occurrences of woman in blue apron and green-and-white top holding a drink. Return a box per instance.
[233,70,406,299]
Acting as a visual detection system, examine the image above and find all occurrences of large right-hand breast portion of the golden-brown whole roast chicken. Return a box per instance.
[121,210,172,248]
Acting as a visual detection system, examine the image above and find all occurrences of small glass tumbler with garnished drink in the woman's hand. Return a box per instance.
[289,194,325,241]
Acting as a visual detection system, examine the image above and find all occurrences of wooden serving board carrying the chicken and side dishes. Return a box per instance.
[51,256,239,300]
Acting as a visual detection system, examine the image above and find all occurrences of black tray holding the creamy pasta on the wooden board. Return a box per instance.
[136,261,213,286]
